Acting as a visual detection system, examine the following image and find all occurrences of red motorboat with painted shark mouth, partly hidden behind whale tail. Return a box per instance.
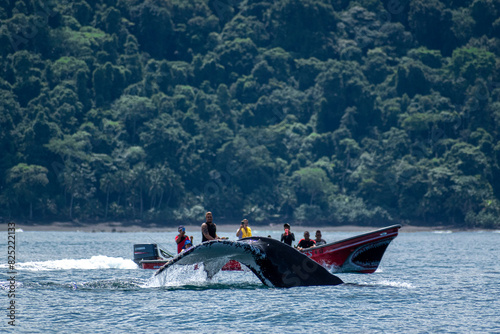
[134,225,401,274]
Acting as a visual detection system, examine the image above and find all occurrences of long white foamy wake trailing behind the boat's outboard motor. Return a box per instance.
[5,255,138,271]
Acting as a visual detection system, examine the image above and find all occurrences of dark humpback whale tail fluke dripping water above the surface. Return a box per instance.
[155,237,343,288]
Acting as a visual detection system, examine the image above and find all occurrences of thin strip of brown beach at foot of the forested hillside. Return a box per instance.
[0,222,489,233]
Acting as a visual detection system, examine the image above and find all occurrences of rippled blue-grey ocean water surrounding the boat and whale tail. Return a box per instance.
[0,228,500,333]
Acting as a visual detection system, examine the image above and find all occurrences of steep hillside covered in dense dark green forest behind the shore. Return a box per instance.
[0,0,500,228]
